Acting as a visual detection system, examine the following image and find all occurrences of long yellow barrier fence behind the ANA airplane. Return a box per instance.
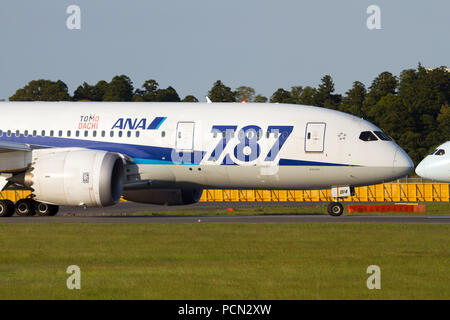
[0,182,450,202]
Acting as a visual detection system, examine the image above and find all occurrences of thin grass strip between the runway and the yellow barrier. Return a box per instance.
[132,202,450,216]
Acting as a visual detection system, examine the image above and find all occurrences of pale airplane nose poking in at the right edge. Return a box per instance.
[416,141,450,182]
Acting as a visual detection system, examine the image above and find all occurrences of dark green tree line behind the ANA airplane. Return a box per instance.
[9,63,450,164]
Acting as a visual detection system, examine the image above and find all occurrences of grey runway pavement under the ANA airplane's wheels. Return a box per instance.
[0,202,450,224]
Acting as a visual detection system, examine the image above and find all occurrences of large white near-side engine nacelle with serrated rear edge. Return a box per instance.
[25,149,125,207]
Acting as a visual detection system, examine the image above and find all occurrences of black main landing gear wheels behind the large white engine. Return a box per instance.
[0,198,59,217]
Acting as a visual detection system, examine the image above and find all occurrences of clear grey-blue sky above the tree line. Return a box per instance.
[0,0,450,100]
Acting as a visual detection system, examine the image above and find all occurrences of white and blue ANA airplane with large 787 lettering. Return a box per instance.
[0,102,413,216]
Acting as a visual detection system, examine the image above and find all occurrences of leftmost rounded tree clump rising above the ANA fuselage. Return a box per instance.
[9,79,72,101]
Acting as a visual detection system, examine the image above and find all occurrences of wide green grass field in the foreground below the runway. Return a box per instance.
[0,224,450,299]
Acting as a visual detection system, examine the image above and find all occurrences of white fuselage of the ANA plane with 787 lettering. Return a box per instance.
[0,102,413,189]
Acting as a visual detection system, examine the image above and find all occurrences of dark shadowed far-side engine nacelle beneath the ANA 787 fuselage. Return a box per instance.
[123,189,203,206]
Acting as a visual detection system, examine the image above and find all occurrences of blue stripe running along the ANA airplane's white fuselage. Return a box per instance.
[0,134,355,166]
